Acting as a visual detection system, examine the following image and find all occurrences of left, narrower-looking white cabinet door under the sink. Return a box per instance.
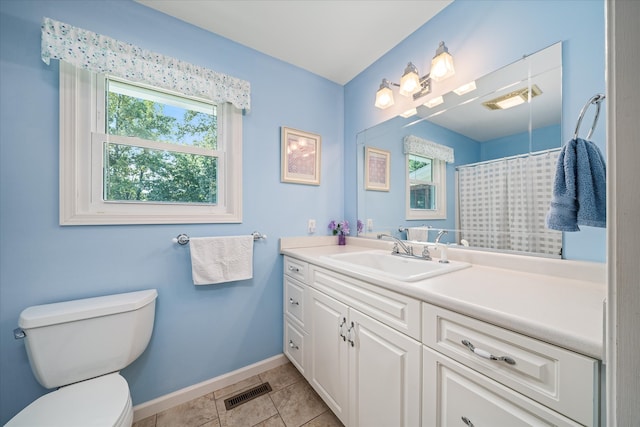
[307,289,349,424]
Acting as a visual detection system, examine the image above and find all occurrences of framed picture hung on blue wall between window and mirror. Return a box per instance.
[280,126,322,185]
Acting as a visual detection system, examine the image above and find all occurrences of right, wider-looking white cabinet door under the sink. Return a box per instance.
[347,309,422,427]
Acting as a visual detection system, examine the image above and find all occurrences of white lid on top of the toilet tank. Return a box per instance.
[18,289,158,329]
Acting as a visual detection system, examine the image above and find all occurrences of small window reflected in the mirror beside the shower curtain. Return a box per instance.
[406,153,447,219]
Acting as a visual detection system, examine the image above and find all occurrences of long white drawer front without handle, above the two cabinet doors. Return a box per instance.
[309,266,420,341]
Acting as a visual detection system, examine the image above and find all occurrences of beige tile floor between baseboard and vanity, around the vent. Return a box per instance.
[133,363,343,427]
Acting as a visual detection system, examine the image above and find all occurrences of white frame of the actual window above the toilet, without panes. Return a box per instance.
[60,61,242,225]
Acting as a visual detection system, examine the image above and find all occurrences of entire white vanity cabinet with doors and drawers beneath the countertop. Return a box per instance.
[284,249,602,427]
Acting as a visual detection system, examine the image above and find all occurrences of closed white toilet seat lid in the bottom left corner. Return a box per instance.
[5,372,133,427]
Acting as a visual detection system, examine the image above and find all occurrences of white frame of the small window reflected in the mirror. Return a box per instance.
[405,153,447,220]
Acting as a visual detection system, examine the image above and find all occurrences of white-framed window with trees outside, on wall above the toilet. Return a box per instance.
[60,61,242,225]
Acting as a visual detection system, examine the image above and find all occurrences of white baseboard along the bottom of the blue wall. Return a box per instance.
[133,354,289,422]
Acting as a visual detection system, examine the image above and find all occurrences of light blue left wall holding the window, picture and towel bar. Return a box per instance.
[0,0,344,424]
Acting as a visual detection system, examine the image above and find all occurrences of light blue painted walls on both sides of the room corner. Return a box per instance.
[0,0,606,423]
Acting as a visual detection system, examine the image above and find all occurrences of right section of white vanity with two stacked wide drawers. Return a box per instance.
[422,303,600,427]
